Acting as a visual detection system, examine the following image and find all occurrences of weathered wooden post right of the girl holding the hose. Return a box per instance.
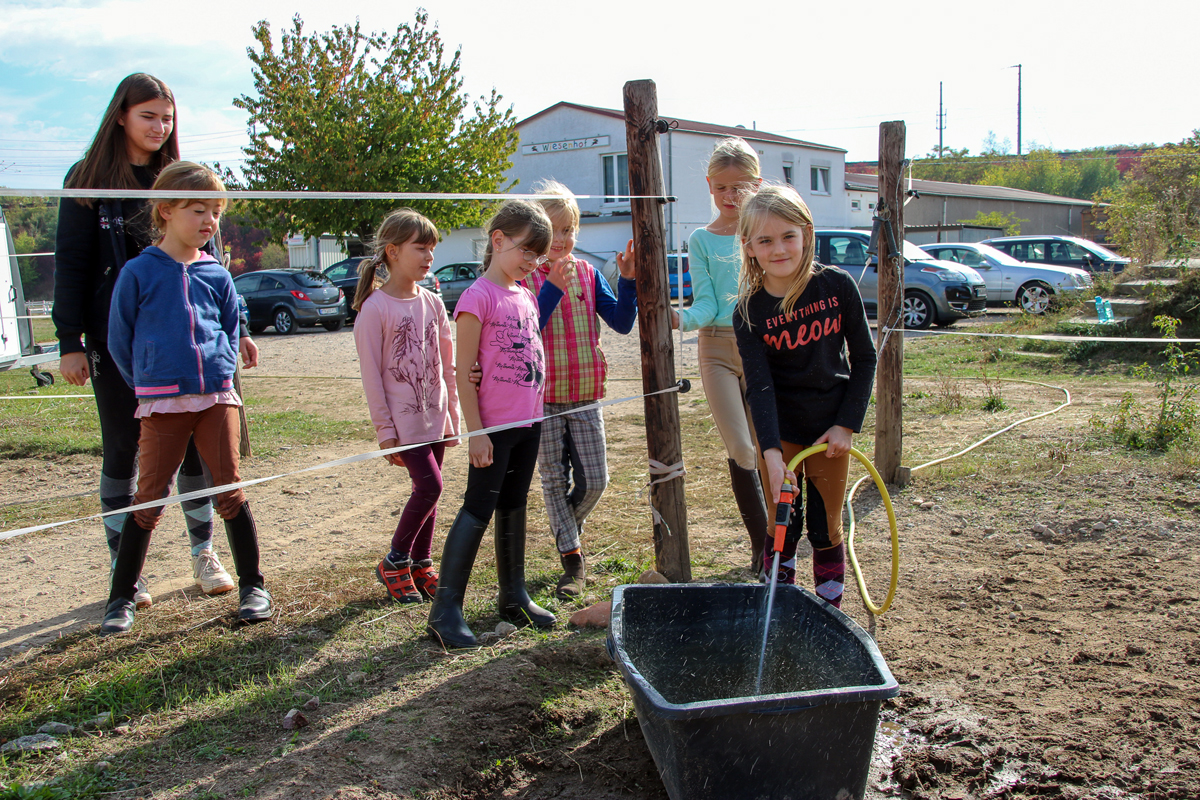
[875,120,908,485]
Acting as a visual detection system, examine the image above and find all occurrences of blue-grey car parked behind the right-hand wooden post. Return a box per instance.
[816,230,988,330]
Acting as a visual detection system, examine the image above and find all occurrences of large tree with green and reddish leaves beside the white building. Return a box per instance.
[226,10,517,241]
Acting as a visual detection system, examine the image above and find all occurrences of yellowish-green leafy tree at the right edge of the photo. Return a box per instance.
[1102,130,1200,264]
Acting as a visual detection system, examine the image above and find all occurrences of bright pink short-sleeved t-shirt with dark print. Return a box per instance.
[454,277,546,428]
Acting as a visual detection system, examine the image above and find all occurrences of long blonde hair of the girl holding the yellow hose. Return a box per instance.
[738,184,817,324]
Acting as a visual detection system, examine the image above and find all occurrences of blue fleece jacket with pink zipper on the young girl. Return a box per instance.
[108,247,238,399]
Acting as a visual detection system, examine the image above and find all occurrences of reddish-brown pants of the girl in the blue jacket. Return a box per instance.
[133,403,246,530]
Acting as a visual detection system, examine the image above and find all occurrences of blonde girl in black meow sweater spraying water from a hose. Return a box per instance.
[733,186,875,607]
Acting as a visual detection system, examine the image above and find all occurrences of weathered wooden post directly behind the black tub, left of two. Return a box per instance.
[625,80,691,583]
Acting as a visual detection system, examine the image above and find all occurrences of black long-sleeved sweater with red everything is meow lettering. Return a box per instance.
[733,264,875,450]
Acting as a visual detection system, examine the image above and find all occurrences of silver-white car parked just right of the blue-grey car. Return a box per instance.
[922,242,1092,314]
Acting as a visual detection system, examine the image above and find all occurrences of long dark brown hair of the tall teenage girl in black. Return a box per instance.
[66,72,179,207]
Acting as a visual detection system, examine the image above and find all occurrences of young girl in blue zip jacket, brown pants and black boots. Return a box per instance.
[100,161,271,634]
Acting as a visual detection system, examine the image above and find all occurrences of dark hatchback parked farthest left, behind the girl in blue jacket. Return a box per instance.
[233,270,347,335]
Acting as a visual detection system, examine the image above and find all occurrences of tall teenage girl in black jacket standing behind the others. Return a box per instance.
[53,73,258,608]
